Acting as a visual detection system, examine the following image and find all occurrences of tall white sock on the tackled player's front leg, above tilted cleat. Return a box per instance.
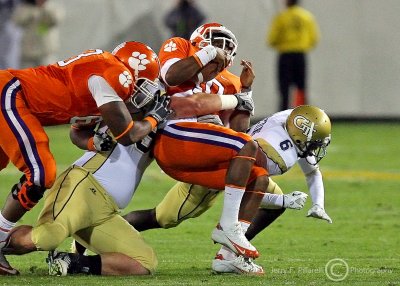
[219,186,244,228]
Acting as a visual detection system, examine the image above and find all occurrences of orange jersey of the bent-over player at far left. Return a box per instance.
[8,50,133,126]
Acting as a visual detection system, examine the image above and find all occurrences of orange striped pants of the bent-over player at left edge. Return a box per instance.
[0,70,56,189]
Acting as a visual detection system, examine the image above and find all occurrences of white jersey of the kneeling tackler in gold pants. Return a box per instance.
[74,132,155,209]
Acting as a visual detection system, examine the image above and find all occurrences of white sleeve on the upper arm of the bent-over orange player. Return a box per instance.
[88,75,122,107]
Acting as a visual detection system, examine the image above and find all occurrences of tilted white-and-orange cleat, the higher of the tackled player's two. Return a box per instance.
[211,222,259,258]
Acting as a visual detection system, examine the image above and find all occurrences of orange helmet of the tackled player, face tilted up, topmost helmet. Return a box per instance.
[190,23,238,60]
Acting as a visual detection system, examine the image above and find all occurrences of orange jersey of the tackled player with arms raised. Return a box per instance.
[158,37,241,95]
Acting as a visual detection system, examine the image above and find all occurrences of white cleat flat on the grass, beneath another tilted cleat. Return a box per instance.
[211,254,264,275]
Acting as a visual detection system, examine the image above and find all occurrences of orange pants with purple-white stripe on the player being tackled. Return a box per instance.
[153,122,267,190]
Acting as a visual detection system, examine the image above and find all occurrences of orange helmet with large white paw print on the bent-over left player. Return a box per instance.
[112,41,160,108]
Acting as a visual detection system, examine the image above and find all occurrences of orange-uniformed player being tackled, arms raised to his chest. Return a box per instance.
[146,23,268,257]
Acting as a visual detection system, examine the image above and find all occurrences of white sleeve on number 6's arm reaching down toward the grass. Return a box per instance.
[299,158,325,208]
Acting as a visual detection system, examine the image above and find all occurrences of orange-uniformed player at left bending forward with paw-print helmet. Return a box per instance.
[0,42,170,275]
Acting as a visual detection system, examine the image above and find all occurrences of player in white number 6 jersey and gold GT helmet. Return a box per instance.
[125,106,332,275]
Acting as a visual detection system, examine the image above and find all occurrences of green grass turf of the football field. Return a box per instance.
[0,122,400,286]
